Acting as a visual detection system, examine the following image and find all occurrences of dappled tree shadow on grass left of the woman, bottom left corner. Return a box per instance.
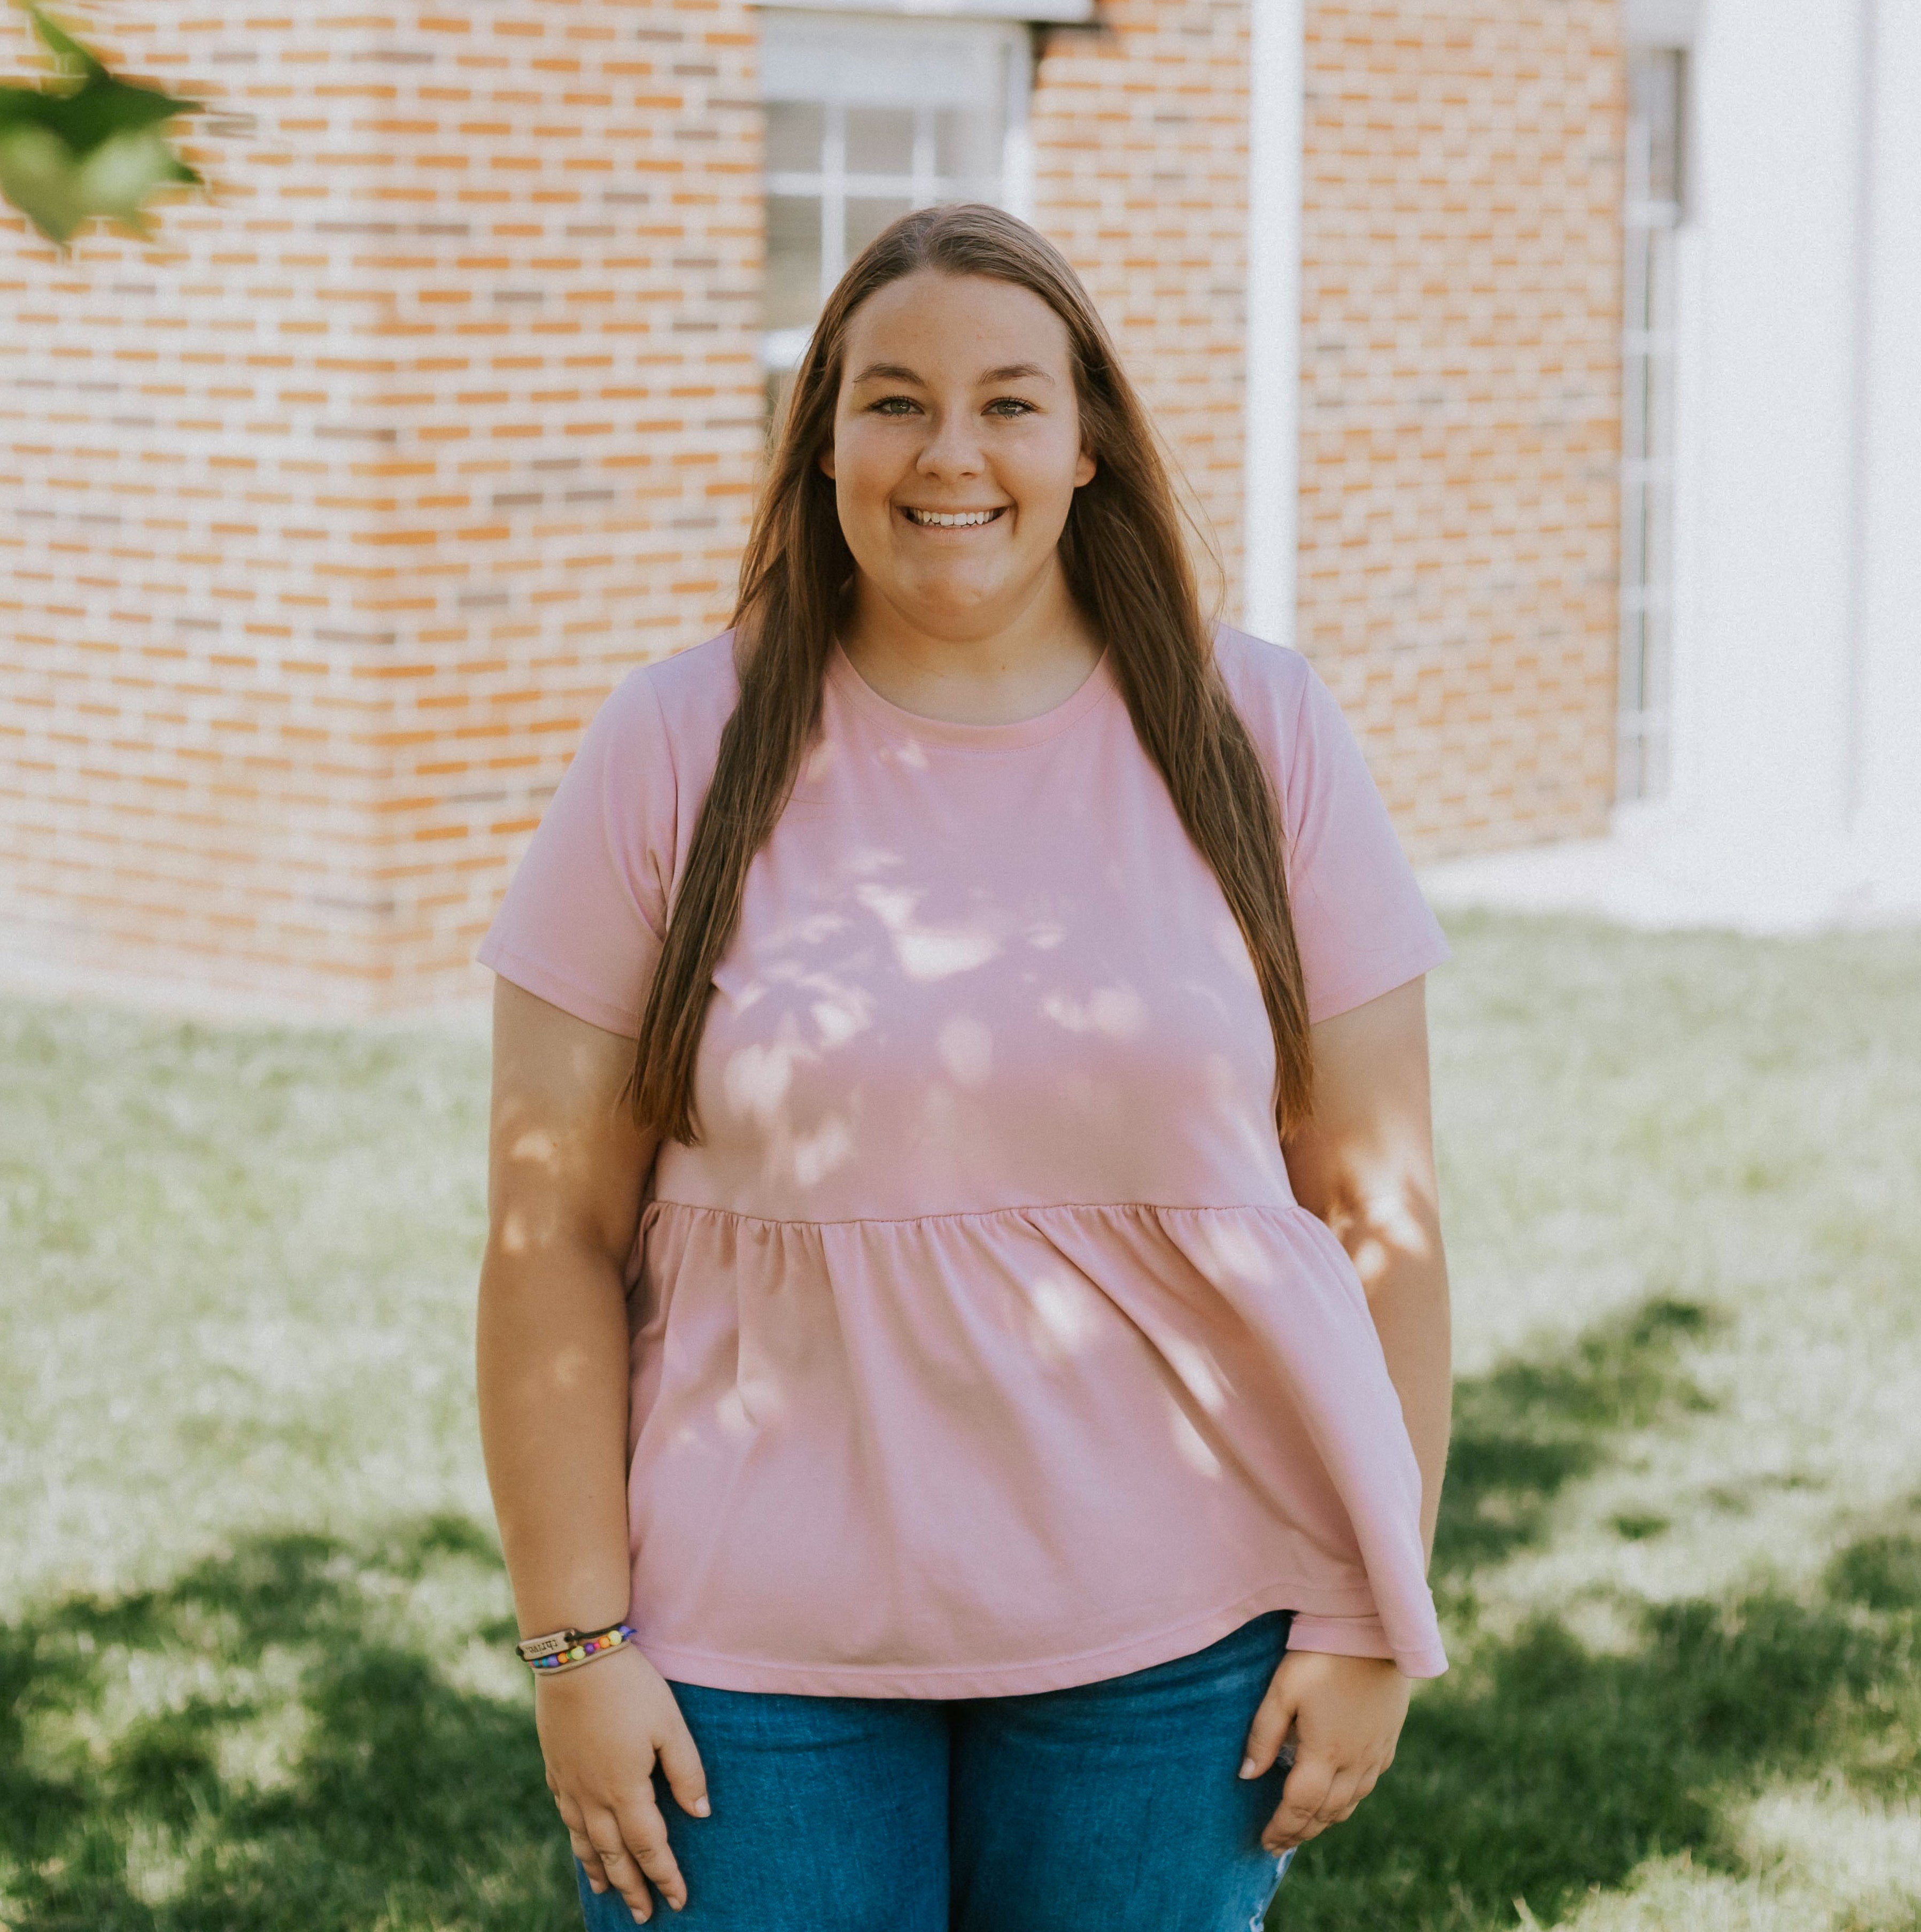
[0,1517,580,1932]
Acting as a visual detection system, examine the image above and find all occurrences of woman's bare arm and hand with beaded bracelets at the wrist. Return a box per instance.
[477,979,706,1919]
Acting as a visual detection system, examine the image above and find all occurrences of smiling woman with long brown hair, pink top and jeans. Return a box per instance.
[479,207,1450,1932]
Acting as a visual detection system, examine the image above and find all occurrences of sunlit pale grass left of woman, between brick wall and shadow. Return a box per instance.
[0,1003,487,1615]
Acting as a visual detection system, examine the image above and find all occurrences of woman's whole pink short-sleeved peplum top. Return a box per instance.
[479,630,1447,1698]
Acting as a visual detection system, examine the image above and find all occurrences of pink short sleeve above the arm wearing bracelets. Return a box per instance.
[475,668,678,1039]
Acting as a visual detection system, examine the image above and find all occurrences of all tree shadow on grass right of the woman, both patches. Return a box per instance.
[1270,1299,1921,1932]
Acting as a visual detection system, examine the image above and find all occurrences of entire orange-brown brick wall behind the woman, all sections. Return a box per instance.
[0,0,1622,1010]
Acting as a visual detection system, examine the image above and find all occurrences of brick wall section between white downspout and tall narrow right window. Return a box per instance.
[1300,0,1625,858]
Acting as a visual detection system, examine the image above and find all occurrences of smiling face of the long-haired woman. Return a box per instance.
[822,268,1094,639]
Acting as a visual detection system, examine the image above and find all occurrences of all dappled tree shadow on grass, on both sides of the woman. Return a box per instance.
[0,1302,1921,1932]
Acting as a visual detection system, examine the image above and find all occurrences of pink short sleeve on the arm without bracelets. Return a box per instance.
[1281,664,1451,1024]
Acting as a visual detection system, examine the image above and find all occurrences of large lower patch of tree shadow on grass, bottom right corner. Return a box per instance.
[1270,1538,1921,1932]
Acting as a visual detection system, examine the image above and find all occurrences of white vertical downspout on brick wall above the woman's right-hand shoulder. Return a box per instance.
[1241,0,1306,645]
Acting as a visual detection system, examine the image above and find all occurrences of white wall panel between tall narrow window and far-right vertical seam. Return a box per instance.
[1676,0,1859,868]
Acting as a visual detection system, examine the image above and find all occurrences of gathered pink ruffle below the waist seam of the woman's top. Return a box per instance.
[628,1200,1446,1696]
